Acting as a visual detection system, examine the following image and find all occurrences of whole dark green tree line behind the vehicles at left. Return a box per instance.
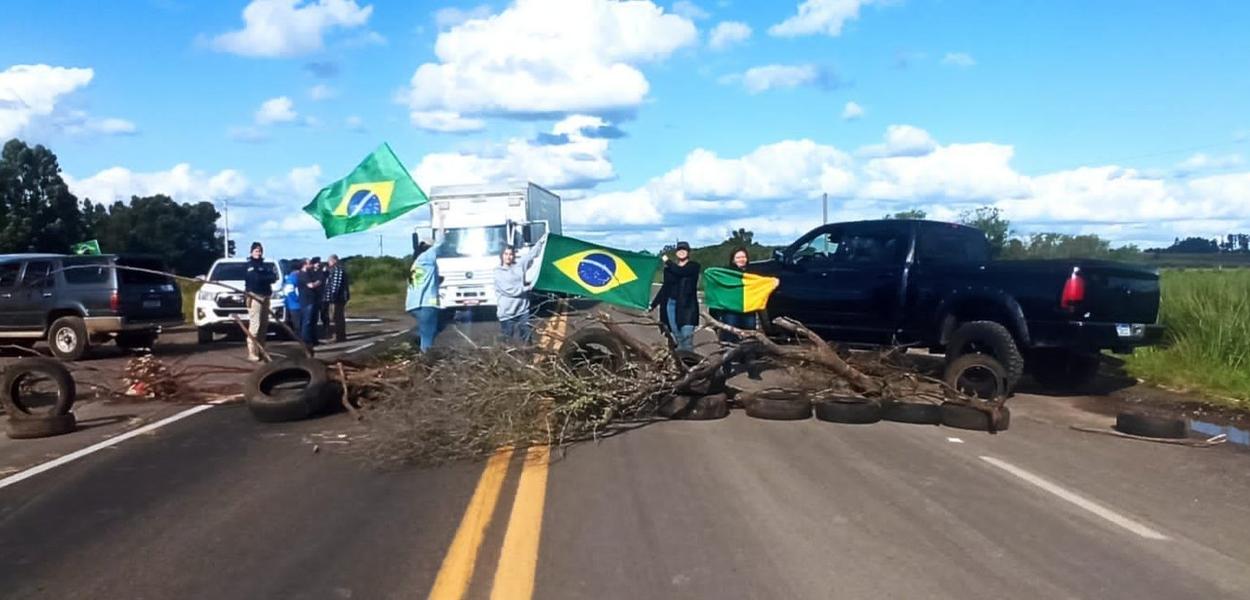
[0,139,225,276]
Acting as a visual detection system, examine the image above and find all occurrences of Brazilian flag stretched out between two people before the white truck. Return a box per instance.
[534,234,660,310]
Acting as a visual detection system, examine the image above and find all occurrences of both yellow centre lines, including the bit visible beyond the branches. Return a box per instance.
[430,306,568,600]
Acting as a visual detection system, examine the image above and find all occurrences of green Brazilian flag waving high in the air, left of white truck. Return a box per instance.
[304,144,430,238]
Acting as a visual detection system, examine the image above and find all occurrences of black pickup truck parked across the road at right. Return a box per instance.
[750,220,1163,389]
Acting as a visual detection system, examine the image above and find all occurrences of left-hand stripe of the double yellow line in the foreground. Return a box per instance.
[430,448,513,600]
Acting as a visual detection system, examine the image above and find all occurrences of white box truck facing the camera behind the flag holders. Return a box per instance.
[430,183,561,310]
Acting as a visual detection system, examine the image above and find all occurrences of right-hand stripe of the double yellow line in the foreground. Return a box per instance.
[490,446,550,600]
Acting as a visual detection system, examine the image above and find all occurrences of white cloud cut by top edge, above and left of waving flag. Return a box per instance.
[211,0,374,58]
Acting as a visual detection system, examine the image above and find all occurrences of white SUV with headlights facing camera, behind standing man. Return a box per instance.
[194,259,286,344]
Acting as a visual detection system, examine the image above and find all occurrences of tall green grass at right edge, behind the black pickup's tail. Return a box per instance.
[1128,269,1250,408]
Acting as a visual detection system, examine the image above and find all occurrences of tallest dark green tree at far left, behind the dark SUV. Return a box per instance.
[0,140,88,253]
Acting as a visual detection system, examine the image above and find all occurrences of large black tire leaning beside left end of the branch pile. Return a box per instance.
[244,356,330,423]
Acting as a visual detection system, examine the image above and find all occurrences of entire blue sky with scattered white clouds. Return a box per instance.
[0,0,1250,255]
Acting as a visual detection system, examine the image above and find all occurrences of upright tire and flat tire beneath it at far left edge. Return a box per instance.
[0,358,78,440]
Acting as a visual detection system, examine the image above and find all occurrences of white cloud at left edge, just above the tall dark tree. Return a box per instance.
[0,65,95,139]
